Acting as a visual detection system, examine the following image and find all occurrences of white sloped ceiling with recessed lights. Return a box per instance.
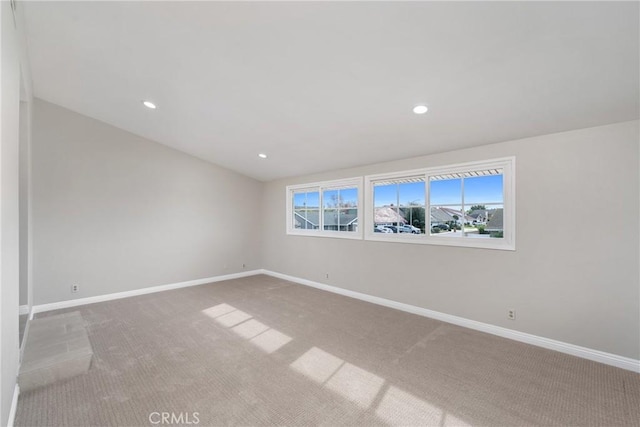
[25,2,640,180]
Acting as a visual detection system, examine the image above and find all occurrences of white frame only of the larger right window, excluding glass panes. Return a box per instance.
[361,156,516,251]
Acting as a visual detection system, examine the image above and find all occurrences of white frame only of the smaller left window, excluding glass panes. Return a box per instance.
[286,177,364,240]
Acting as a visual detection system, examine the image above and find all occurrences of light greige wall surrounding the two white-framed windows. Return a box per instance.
[263,121,640,359]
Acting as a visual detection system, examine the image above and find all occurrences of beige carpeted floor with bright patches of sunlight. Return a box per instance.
[15,276,640,426]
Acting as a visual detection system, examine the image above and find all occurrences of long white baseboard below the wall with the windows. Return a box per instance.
[261,270,640,373]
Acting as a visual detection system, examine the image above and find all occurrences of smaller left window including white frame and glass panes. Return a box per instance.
[287,178,362,239]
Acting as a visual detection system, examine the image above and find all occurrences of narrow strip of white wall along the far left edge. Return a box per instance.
[0,1,31,425]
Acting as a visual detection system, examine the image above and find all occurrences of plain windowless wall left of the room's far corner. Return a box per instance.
[32,99,262,304]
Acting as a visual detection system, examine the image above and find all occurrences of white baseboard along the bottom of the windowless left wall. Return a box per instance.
[31,270,262,317]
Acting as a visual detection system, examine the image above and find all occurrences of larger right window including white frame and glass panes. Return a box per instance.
[365,158,515,249]
